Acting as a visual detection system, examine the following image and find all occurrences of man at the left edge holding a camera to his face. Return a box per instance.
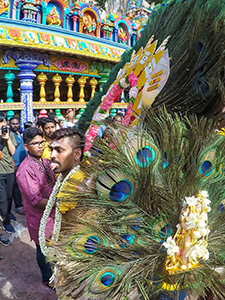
[0,111,16,240]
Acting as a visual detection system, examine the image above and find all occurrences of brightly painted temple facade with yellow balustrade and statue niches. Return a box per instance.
[0,0,152,124]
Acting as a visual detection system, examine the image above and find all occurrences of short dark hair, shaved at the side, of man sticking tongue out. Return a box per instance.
[51,128,85,160]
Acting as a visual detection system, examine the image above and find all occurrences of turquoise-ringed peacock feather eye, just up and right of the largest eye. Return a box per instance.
[135,146,156,168]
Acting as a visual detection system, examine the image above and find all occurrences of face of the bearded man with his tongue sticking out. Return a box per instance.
[50,137,81,174]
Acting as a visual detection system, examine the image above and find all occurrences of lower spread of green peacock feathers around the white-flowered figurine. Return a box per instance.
[50,108,225,300]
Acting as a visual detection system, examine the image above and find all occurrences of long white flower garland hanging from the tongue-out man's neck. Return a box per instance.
[38,165,80,256]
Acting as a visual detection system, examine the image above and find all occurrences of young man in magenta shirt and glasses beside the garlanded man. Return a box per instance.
[16,127,55,287]
